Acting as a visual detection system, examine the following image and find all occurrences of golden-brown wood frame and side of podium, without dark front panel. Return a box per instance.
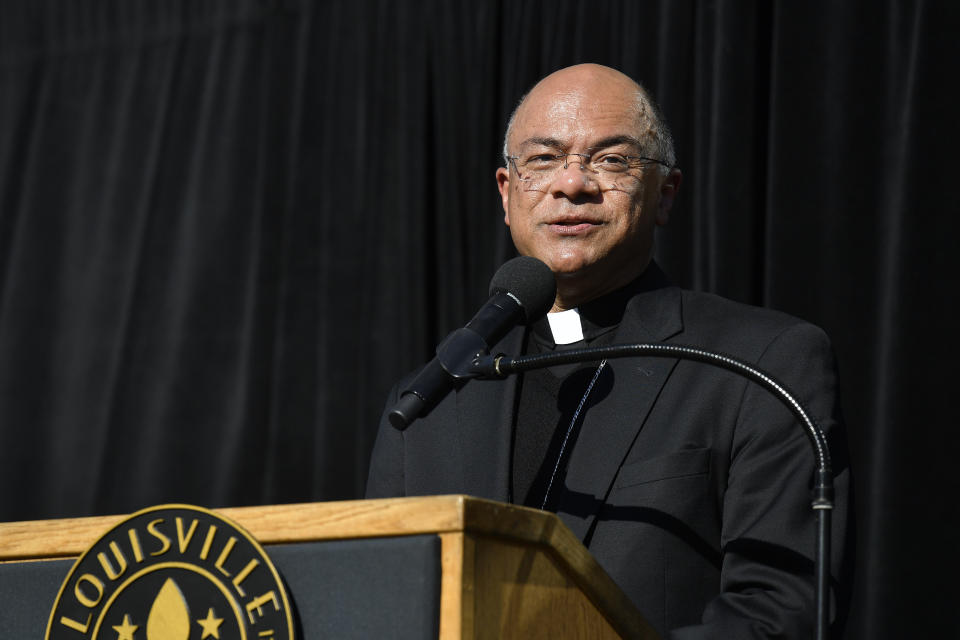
[0,495,658,640]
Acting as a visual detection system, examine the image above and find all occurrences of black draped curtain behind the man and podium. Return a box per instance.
[0,0,960,639]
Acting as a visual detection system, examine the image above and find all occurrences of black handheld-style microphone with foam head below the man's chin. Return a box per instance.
[389,256,557,431]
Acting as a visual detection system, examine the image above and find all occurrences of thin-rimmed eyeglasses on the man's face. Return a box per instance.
[507,151,670,191]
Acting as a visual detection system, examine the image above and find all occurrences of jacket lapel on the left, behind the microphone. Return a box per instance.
[456,327,525,502]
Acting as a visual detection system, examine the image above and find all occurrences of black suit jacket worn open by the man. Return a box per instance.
[367,265,851,640]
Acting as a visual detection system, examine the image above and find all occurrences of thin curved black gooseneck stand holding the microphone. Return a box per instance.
[464,343,833,640]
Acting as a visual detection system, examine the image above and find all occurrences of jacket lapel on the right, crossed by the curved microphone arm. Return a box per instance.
[557,287,683,540]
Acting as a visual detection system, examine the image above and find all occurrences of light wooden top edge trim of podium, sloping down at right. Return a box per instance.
[0,495,652,637]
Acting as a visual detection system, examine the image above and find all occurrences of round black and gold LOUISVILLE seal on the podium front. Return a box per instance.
[46,504,294,640]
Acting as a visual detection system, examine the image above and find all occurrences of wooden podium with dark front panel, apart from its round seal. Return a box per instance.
[0,496,658,640]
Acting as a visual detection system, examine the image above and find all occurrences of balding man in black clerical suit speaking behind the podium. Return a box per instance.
[367,65,849,639]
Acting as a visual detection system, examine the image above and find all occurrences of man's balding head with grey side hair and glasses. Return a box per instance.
[497,64,681,311]
